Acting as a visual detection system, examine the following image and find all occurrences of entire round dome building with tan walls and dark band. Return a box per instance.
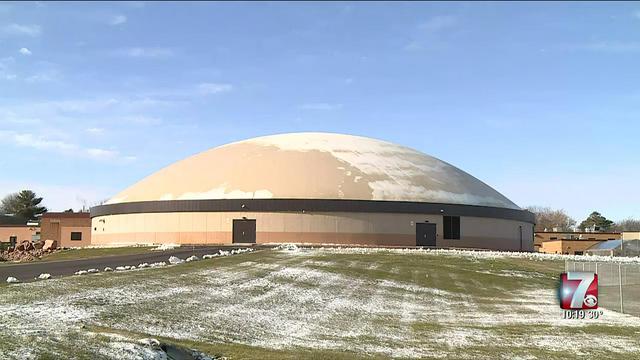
[91,133,534,251]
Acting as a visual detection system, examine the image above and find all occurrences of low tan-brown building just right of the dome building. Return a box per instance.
[533,231,622,255]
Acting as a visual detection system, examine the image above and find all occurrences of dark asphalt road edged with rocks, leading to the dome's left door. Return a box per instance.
[0,246,262,282]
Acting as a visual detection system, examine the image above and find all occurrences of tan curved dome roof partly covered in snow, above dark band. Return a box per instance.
[107,133,519,209]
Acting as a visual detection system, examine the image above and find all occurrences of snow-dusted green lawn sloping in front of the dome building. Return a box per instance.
[0,249,640,359]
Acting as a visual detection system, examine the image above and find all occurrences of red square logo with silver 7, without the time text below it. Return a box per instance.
[560,271,598,310]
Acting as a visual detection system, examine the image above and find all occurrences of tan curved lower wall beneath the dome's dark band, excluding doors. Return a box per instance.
[92,212,533,251]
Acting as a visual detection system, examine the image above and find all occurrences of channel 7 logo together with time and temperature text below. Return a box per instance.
[558,271,602,319]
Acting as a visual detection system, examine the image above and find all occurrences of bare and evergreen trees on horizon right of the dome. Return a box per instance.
[527,206,640,231]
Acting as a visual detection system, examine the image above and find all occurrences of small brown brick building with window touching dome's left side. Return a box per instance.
[40,212,91,247]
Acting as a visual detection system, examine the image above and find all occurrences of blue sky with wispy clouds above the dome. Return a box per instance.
[0,2,640,220]
